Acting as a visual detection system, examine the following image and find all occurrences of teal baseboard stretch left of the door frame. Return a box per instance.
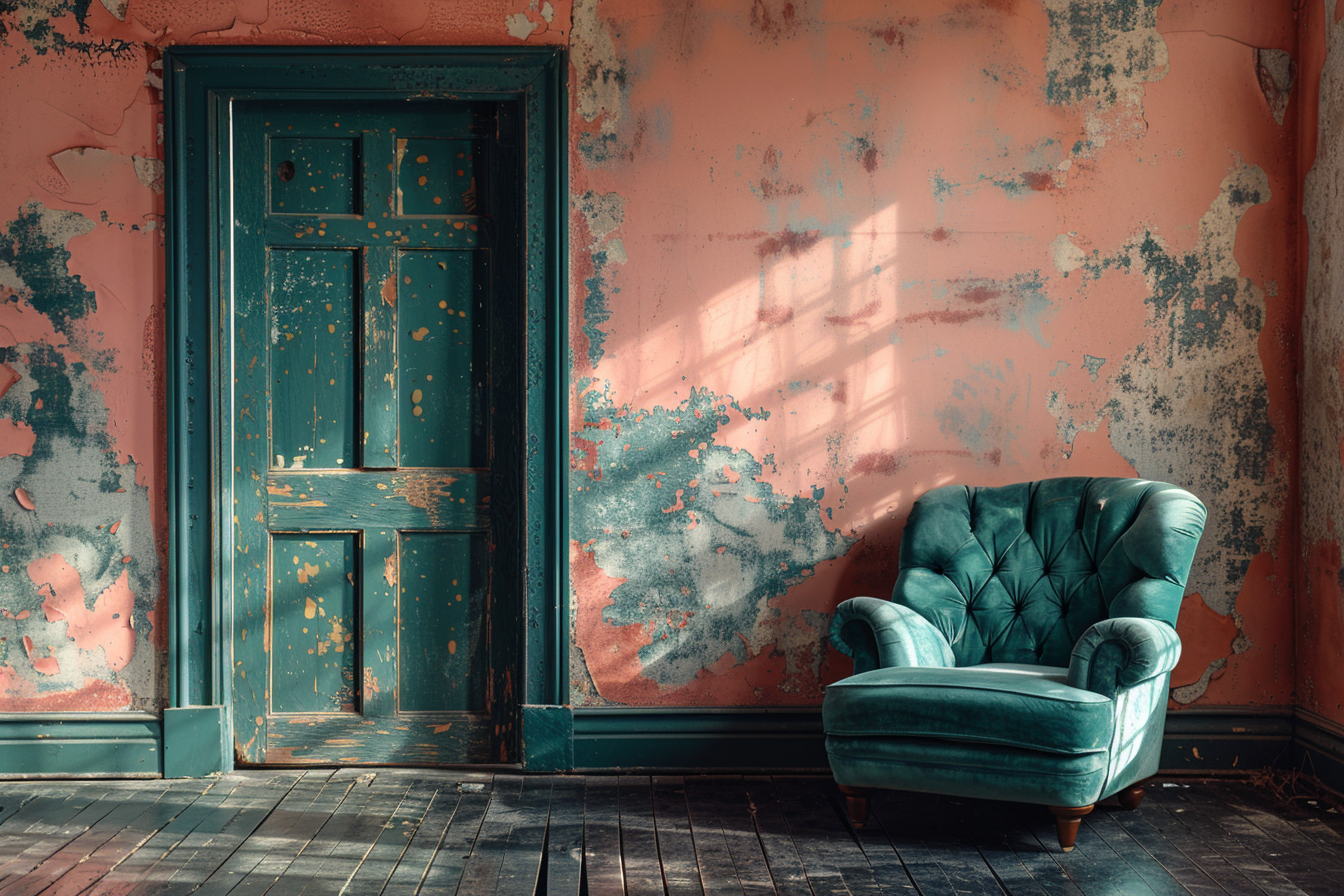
[0,712,163,778]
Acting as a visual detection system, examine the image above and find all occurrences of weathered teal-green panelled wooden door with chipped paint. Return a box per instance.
[224,101,523,764]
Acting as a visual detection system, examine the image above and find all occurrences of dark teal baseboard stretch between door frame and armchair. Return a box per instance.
[574,707,828,771]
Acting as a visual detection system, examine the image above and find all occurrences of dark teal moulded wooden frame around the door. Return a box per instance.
[164,47,573,776]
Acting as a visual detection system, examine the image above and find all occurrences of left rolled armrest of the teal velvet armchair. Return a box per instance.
[831,598,957,674]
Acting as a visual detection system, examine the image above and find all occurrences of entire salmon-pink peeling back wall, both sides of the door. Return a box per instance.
[0,0,1306,711]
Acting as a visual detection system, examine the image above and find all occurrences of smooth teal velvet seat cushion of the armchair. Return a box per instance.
[821,662,1114,755]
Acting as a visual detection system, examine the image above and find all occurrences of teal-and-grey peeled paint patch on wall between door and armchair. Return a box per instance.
[571,388,855,688]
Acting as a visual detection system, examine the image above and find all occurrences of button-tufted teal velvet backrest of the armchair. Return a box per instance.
[891,477,1206,666]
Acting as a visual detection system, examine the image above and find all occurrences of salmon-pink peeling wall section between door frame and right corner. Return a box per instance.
[571,0,1297,705]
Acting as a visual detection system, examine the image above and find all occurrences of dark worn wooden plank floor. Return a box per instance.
[0,770,1344,896]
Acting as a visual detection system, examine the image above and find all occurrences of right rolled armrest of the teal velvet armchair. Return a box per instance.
[1068,617,1180,697]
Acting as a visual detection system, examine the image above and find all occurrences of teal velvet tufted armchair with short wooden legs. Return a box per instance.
[823,477,1206,852]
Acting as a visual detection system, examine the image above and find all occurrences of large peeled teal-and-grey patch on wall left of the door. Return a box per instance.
[0,203,164,711]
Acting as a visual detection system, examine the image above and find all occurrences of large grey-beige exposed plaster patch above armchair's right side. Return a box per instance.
[1047,159,1286,658]
